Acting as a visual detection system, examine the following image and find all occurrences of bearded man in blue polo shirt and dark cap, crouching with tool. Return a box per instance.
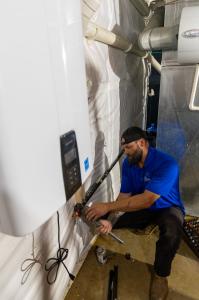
[86,127,184,300]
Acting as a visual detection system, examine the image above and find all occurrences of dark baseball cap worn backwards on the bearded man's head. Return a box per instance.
[121,126,148,145]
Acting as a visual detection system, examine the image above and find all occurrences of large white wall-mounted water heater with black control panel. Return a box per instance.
[0,0,92,236]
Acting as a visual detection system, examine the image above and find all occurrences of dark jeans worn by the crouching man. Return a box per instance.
[113,207,184,276]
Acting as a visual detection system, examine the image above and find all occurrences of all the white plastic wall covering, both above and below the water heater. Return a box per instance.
[0,0,147,300]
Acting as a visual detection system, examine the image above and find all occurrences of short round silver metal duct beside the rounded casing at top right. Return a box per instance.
[138,25,179,50]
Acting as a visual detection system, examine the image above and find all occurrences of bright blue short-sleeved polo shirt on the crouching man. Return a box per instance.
[120,147,184,213]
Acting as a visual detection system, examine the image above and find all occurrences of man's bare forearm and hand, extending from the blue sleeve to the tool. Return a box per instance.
[86,190,160,220]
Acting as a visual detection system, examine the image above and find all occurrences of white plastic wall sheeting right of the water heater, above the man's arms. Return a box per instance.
[82,1,147,205]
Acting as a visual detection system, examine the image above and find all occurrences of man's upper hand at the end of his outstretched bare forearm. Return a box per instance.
[85,203,109,221]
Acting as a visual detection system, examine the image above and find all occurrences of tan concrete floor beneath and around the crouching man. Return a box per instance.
[65,229,199,300]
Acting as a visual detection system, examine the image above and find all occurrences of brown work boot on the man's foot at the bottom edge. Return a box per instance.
[150,274,169,300]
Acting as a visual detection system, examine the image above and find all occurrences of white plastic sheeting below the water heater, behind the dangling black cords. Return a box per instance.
[0,201,92,300]
